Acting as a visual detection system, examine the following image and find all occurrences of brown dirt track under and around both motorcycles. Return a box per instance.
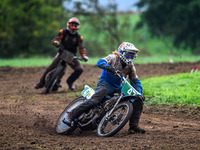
[0,62,200,150]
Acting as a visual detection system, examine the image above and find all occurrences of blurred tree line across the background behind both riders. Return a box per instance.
[0,0,200,58]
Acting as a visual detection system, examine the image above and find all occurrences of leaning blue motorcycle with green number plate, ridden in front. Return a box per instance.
[56,72,141,137]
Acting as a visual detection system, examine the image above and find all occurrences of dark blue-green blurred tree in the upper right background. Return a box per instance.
[137,0,200,53]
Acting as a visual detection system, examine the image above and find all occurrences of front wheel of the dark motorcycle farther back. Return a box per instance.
[44,65,63,94]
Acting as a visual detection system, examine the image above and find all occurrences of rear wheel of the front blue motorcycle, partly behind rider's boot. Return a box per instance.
[56,97,85,134]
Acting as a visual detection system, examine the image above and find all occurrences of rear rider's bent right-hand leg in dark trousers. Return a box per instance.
[66,59,83,90]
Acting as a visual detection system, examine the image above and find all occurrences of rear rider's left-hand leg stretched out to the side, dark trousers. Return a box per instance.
[34,53,60,89]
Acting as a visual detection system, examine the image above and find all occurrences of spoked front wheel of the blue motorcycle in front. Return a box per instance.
[97,102,133,137]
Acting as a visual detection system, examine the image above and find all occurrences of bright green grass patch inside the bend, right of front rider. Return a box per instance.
[141,72,200,106]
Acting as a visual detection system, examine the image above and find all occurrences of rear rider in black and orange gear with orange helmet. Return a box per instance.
[34,17,88,91]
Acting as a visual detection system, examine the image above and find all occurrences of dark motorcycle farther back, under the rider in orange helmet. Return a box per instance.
[44,45,83,94]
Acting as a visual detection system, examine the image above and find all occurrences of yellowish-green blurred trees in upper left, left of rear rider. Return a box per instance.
[0,0,66,58]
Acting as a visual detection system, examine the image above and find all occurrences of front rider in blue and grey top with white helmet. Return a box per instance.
[65,42,146,134]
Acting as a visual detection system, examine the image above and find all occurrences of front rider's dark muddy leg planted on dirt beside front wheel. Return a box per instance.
[129,96,146,133]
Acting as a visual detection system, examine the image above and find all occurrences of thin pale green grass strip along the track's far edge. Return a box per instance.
[0,55,200,67]
